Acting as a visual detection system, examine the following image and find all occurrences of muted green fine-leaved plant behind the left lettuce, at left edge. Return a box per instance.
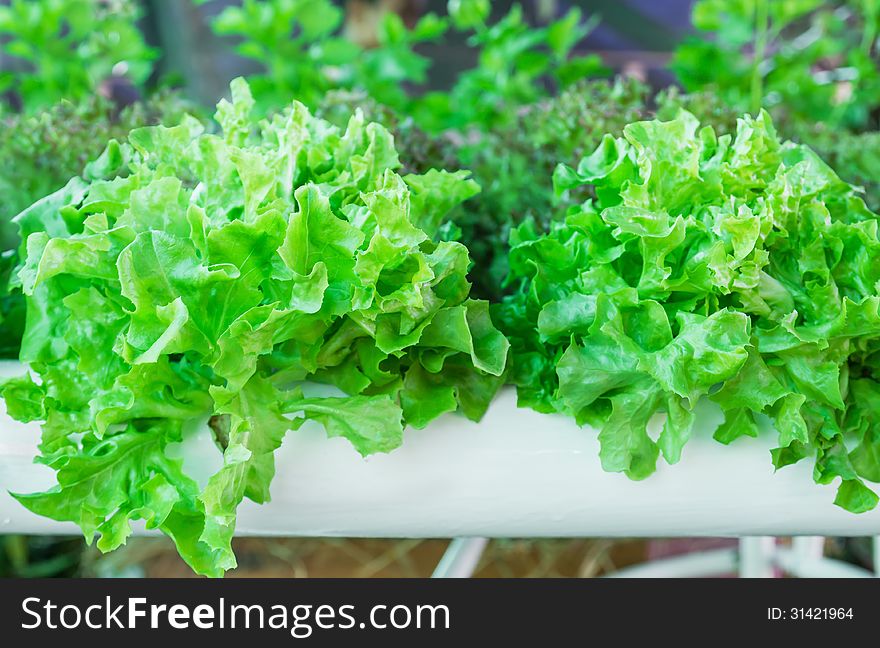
[0,91,191,358]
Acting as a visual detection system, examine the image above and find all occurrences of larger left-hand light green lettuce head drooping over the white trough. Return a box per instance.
[2,80,508,575]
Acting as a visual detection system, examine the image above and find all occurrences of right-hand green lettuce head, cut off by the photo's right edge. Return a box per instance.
[500,111,880,512]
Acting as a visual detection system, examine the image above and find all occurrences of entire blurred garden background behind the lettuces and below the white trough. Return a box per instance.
[0,0,880,576]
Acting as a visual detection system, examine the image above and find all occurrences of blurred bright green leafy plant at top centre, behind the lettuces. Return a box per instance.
[196,0,608,133]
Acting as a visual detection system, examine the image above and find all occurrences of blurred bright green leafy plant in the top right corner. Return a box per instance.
[672,0,880,134]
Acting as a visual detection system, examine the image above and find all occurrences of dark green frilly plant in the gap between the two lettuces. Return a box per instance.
[452,79,650,300]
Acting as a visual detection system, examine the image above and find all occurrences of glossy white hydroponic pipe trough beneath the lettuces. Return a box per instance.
[0,363,880,538]
